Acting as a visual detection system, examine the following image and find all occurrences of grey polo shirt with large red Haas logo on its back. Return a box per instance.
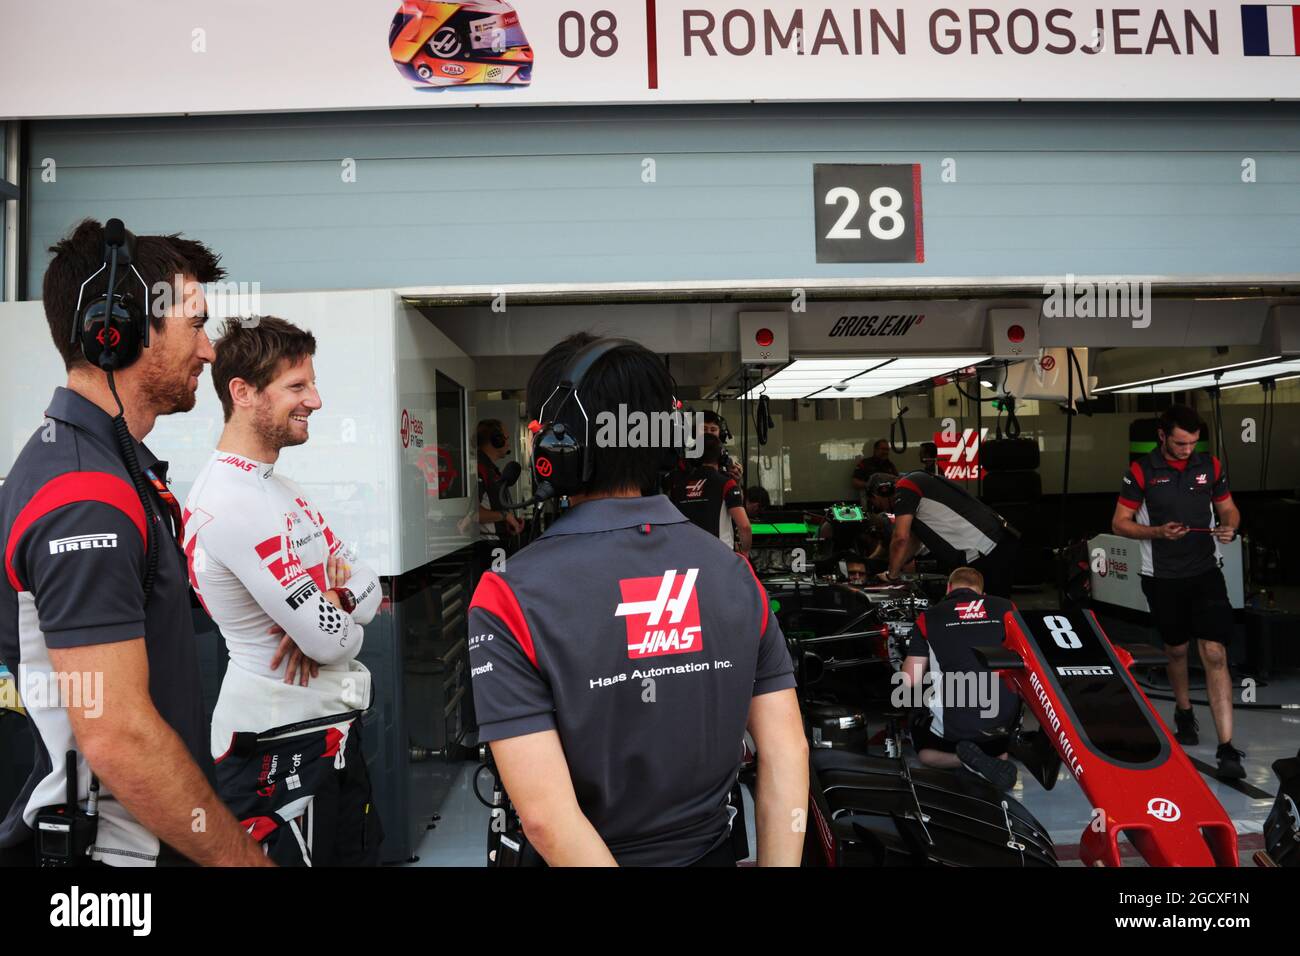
[469,494,794,866]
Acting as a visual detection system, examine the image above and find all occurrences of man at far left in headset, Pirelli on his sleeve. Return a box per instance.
[0,220,267,866]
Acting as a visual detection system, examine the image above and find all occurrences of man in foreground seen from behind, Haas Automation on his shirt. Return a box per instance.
[469,333,807,866]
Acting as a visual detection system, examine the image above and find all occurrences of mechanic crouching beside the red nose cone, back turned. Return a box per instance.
[896,567,1021,790]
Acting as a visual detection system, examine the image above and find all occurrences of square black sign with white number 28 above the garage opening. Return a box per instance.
[813,163,926,263]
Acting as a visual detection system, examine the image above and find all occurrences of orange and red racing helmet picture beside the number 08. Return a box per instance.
[389,0,533,87]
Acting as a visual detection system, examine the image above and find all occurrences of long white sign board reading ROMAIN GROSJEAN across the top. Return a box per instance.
[0,0,1300,118]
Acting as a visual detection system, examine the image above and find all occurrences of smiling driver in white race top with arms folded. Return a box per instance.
[185,316,382,866]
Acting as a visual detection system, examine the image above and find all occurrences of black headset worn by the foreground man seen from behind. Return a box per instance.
[528,338,688,499]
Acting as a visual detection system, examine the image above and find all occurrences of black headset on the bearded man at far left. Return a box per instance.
[70,219,150,372]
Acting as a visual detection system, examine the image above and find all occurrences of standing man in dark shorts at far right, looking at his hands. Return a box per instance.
[1110,405,1245,780]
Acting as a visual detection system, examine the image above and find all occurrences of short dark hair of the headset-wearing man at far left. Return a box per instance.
[40,219,226,372]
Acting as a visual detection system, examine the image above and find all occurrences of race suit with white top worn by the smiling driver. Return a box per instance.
[185,450,382,866]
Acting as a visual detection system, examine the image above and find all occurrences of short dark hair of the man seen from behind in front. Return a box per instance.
[527,332,673,494]
